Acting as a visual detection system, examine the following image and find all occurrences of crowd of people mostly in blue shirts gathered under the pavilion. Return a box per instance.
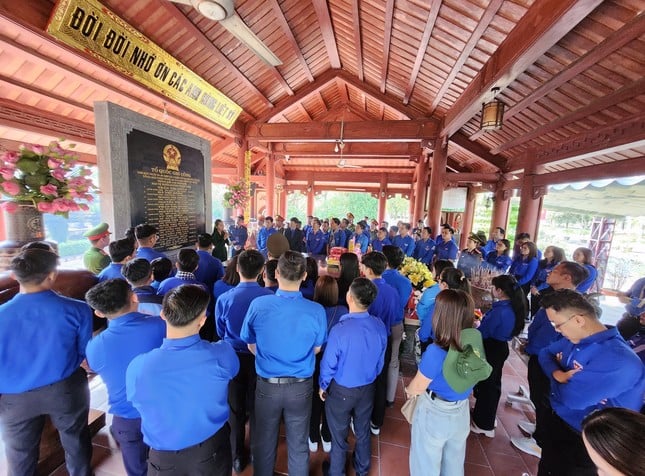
[0,213,645,476]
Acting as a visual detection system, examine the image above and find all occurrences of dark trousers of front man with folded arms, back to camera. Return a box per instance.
[148,423,233,476]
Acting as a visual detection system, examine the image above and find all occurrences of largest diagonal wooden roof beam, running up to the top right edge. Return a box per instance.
[442,0,602,137]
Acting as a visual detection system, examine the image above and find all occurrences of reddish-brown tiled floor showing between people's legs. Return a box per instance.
[0,352,538,476]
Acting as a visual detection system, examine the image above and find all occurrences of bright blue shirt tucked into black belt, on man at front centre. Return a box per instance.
[240,289,327,378]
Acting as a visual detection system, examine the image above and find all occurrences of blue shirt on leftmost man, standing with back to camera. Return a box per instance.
[0,291,92,394]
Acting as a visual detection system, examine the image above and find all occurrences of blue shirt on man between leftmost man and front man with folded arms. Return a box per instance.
[87,312,166,418]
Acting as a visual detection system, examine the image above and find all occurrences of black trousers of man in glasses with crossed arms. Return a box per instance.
[538,410,597,476]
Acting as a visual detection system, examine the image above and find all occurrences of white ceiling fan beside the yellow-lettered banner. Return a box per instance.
[170,0,282,66]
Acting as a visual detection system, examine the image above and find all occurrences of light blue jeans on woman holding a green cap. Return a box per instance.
[410,393,470,476]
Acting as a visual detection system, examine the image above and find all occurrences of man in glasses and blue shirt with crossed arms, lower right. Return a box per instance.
[538,290,645,475]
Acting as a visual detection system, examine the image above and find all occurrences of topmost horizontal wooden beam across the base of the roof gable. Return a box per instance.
[246,120,438,142]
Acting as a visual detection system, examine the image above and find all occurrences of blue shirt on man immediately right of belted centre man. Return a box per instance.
[319,312,387,390]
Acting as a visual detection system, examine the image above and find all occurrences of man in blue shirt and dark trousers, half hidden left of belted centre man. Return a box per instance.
[215,250,273,473]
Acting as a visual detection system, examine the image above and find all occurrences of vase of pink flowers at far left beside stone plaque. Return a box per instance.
[0,141,96,268]
